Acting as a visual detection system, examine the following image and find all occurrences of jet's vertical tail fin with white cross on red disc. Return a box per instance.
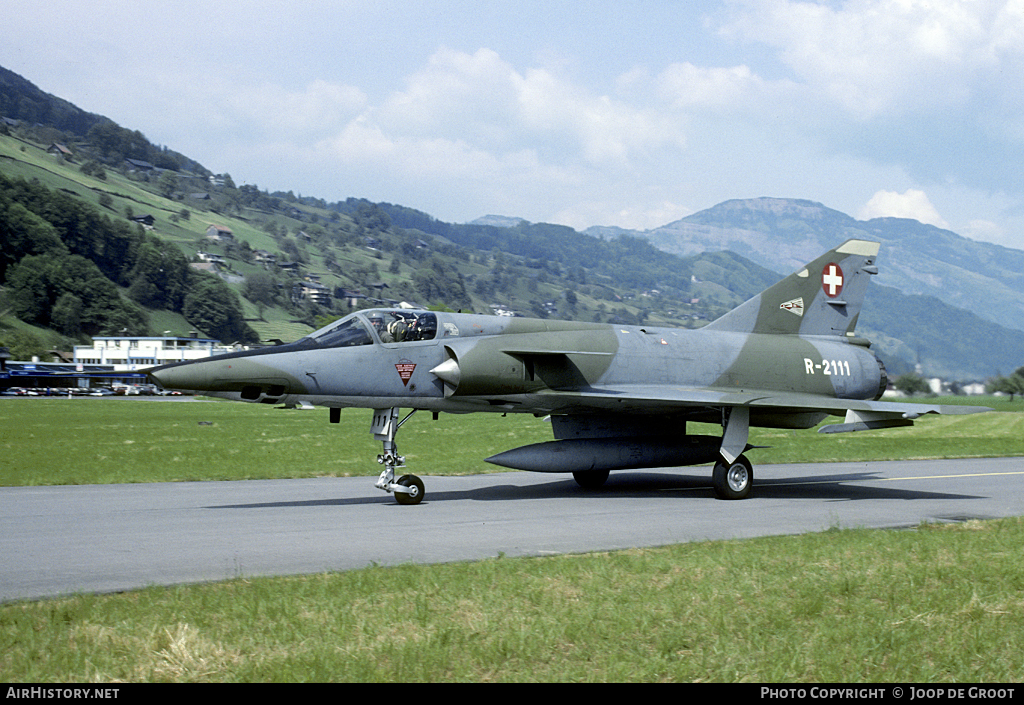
[707,240,879,335]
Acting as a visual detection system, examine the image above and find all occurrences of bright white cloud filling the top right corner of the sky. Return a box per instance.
[723,0,1024,119]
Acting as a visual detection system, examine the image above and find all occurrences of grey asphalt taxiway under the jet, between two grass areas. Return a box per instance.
[0,458,1024,600]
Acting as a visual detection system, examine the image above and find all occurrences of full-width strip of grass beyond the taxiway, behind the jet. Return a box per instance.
[0,398,1024,486]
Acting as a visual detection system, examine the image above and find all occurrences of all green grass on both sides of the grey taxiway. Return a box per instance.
[0,399,1024,683]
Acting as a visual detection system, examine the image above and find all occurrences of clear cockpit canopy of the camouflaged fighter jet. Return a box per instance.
[309,308,437,347]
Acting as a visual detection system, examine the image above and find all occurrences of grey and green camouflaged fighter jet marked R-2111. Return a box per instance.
[150,240,987,504]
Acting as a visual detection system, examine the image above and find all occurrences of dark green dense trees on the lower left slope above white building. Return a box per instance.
[0,174,258,342]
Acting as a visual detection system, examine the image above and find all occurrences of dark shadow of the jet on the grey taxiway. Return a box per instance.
[206,472,983,510]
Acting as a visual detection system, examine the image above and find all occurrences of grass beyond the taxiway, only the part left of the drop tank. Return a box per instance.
[0,398,551,486]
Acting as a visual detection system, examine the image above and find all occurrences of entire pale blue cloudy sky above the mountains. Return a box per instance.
[0,0,1024,248]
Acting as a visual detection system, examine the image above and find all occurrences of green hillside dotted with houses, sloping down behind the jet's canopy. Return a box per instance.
[0,131,773,352]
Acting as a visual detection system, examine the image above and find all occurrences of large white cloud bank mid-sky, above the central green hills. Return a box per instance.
[256,48,690,227]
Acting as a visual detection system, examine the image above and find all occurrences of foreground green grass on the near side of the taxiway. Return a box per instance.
[0,519,1024,685]
